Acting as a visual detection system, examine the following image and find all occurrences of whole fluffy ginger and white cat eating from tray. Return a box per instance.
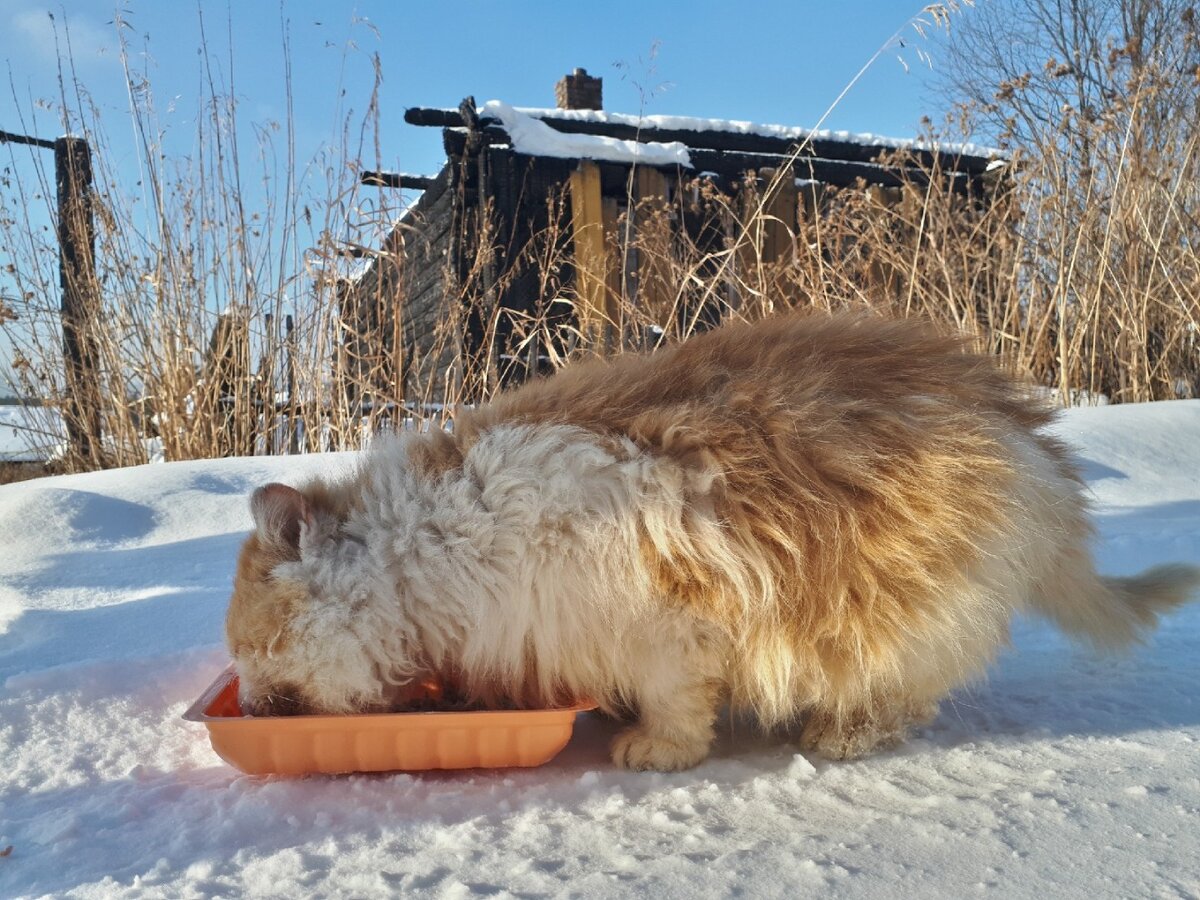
[227,316,1200,769]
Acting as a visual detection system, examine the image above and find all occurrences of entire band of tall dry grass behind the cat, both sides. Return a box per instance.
[0,14,1200,469]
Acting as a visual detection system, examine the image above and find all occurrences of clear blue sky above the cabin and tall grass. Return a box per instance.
[0,0,970,381]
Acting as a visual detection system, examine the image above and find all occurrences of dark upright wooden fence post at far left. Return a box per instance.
[54,136,103,463]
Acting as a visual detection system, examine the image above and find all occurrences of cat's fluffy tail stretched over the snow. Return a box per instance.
[1033,554,1200,649]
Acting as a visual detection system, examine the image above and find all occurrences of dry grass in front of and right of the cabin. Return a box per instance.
[416,116,1200,415]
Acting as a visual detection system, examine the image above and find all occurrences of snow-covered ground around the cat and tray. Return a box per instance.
[0,401,1200,900]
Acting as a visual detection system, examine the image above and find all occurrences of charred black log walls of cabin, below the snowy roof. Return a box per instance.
[361,117,1003,403]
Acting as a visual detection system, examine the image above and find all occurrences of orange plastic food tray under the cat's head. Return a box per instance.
[184,666,595,775]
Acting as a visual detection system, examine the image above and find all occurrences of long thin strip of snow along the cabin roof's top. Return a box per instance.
[479,101,1007,162]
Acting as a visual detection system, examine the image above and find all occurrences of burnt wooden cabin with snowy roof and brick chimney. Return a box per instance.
[342,70,996,402]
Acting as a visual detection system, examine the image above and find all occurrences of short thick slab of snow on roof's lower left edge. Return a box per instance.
[479,100,691,169]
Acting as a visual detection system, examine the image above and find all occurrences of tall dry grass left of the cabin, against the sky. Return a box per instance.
[0,15,397,469]
